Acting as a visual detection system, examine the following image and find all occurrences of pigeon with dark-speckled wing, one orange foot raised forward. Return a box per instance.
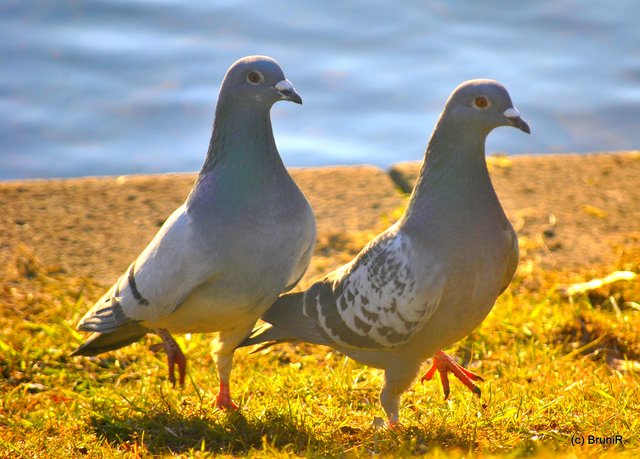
[242,80,530,425]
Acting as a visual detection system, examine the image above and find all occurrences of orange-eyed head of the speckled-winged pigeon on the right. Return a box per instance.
[444,80,531,134]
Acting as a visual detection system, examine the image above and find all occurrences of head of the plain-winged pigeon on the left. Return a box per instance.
[220,56,302,109]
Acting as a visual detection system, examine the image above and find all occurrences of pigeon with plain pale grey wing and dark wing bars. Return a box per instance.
[72,56,316,408]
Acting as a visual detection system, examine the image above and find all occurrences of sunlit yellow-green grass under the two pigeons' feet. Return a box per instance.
[0,243,640,458]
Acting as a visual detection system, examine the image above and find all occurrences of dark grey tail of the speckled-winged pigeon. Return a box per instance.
[238,292,331,350]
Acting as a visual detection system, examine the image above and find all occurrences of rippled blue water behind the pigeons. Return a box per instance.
[0,0,640,179]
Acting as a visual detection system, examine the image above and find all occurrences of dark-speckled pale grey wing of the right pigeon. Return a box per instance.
[304,231,444,349]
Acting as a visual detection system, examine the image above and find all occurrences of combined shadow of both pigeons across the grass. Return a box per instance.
[87,411,478,456]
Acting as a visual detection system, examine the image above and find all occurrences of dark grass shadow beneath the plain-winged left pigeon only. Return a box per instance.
[91,412,327,455]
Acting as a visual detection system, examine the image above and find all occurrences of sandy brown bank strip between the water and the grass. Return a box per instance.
[0,152,640,285]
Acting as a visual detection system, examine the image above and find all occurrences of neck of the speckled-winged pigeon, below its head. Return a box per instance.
[404,119,497,225]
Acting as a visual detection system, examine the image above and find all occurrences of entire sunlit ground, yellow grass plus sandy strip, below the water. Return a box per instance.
[0,154,640,458]
